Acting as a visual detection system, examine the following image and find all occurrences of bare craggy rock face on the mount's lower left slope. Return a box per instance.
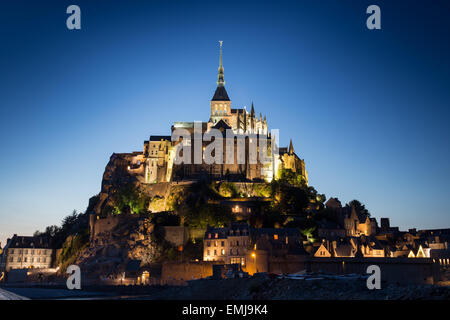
[76,215,161,279]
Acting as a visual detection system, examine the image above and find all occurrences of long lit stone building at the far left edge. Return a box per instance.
[0,234,54,271]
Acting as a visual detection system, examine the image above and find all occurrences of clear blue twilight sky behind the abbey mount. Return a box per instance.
[0,0,450,244]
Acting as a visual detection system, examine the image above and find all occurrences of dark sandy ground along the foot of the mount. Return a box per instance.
[4,277,450,300]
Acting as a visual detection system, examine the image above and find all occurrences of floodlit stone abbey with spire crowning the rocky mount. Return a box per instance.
[127,42,308,184]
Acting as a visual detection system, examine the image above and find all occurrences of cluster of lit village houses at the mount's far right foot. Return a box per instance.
[313,198,450,266]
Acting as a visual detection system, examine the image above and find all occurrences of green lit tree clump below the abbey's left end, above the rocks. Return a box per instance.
[112,184,150,214]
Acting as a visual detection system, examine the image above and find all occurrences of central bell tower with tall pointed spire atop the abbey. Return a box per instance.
[211,41,231,124]
